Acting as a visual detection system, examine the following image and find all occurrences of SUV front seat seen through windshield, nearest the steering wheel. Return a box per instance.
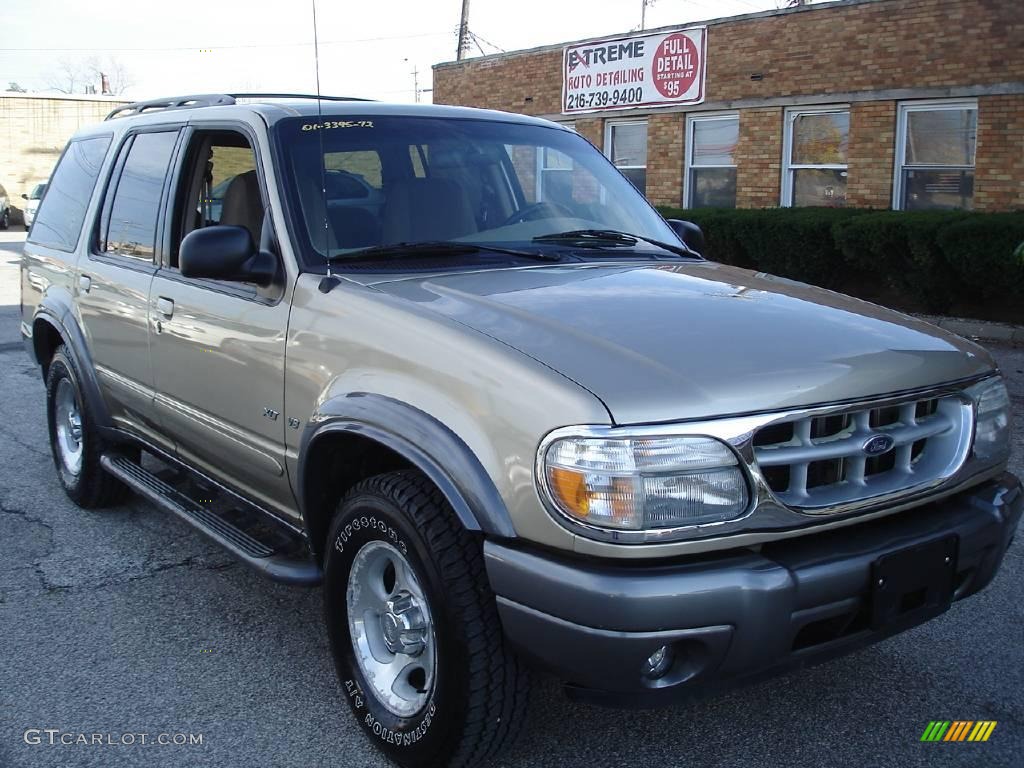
[381,178,476,243]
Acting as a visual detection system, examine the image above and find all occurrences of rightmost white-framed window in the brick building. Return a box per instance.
[894,101,978,211]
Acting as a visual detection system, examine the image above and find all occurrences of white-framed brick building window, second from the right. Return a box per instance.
[782,108,850,208]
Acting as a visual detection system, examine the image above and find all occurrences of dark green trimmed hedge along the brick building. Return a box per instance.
[659,208,1024,323]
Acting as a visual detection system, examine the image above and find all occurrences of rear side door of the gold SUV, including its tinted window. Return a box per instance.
[76,127,179,449]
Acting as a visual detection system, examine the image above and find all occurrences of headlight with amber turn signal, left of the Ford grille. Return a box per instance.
[538,436,750,541]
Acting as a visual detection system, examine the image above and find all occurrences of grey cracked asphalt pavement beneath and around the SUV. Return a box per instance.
[0,232,1024,768]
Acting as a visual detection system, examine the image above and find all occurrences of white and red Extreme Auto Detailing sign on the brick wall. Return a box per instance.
[562,27,708,114]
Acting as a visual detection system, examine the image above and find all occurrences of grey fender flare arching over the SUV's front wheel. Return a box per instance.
[297,392,516,539]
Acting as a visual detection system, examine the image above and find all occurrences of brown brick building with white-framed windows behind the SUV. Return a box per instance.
[433,0,1024,211]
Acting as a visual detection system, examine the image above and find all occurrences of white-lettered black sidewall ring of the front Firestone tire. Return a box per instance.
[324,493,467,766]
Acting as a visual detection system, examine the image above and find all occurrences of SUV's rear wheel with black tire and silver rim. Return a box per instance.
[46,346,138,509]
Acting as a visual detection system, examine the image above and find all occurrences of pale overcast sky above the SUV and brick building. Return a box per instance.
[0,0,806,101]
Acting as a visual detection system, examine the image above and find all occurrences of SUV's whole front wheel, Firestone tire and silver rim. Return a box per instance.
[324,471,528,768]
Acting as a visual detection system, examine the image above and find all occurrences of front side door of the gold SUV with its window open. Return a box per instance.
[150,129,295,517]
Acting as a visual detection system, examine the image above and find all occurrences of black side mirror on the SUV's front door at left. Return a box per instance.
[178,224,276,286]
